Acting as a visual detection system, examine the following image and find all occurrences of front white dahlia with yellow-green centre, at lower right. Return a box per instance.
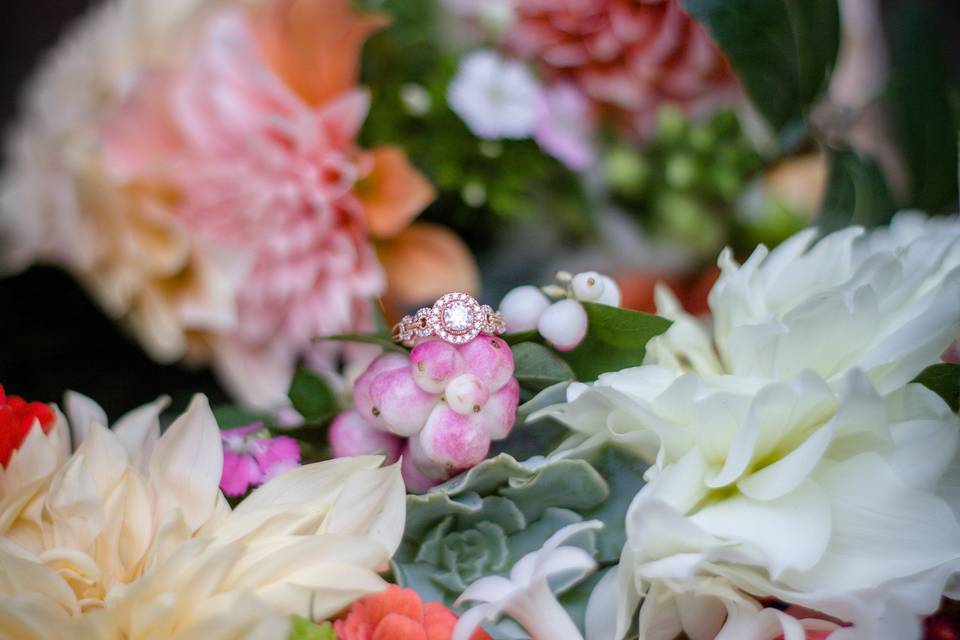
[551,365,960,640]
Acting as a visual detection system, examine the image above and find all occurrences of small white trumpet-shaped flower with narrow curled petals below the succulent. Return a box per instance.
[453,520,603,640]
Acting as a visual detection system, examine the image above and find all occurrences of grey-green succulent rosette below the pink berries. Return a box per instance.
[393,445,647,639]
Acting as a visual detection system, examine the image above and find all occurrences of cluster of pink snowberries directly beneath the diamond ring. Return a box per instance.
[329,335,520,492]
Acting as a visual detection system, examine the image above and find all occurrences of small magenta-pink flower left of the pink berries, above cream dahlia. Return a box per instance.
[220,422,300,496]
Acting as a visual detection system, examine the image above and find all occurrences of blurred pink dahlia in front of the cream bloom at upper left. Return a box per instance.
[104,3,432,405]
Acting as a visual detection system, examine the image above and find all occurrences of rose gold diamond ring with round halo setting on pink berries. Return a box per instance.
[393,293,507,344]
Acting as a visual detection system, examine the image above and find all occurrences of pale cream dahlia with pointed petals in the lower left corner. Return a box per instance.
[0,397,404,640]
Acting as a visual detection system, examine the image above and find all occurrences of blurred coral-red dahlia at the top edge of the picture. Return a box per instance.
[507,0,739,136]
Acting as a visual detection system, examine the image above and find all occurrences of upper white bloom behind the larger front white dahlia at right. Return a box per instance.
[647,213,960,393]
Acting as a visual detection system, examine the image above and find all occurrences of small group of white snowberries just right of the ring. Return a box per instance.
[500,271,620,351]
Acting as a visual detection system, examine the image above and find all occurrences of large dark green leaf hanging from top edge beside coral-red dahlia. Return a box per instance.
[683,0,840,132]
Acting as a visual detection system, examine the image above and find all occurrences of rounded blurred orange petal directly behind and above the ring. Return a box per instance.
[380,222,480,306]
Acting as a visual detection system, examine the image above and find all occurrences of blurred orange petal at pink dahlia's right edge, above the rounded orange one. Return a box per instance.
[356,147,437,238]
